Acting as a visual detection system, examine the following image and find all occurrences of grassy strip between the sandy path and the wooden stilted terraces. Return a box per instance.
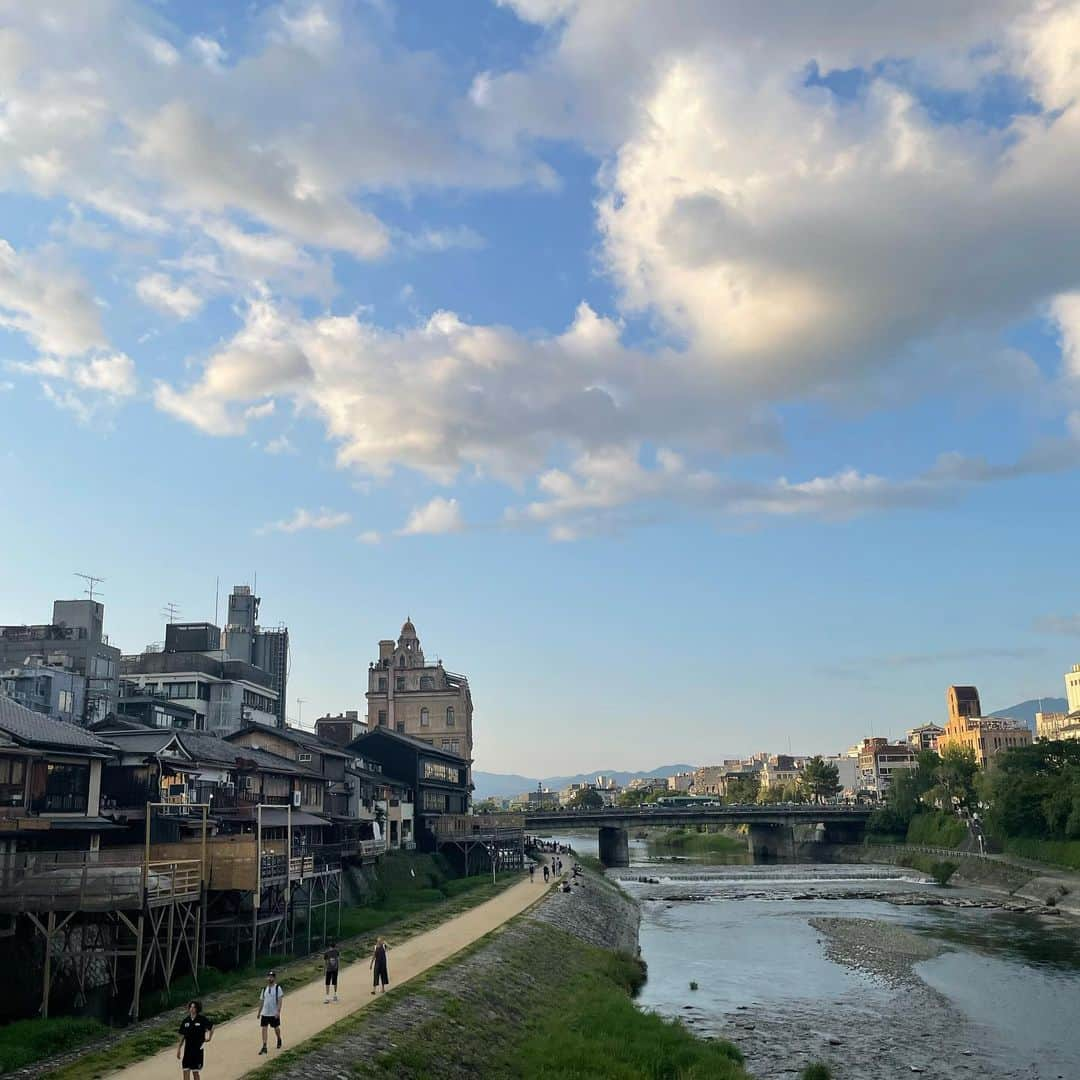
[12,853,522,1080]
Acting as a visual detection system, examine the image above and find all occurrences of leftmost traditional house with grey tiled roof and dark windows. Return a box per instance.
[0,697,116,854]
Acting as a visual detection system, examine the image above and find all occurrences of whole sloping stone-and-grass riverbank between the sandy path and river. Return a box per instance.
[254,870,748,1080]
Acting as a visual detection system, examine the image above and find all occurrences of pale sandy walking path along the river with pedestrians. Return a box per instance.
[110,855,571,1080]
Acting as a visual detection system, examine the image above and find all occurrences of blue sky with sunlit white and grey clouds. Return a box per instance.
[0,0,1080,775]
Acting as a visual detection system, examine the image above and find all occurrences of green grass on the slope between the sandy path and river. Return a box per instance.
[251,911,748,1080]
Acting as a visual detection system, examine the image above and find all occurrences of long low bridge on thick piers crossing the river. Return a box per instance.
[525,804,873,866]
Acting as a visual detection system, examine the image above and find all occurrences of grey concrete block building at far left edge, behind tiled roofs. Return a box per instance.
[0,600,120,725]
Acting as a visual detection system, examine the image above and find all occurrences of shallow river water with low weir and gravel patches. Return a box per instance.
[540,834,1080,1080]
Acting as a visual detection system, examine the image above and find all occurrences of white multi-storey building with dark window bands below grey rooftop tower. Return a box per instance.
[120,624,280,735]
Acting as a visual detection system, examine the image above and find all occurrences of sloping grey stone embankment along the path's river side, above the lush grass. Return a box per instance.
[257,872,639,1080]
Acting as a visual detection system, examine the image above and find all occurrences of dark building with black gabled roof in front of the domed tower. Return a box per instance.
[348,725,472,851]
